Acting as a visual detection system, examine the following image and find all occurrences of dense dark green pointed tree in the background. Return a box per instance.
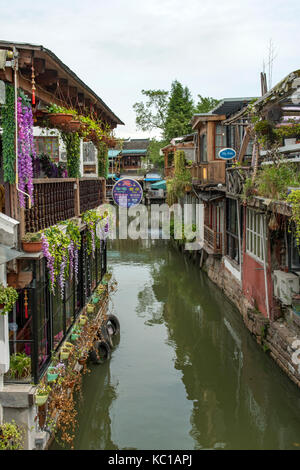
[164,80,194,141]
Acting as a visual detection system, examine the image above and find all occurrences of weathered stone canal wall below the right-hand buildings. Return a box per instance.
[203,256,300,388]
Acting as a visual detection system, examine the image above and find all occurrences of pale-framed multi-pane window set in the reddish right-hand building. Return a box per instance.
[246,209,266,261]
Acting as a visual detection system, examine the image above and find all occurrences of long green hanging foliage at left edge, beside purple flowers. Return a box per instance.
[1,83,16,183]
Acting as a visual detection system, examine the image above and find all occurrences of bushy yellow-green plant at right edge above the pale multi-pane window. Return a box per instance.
[256,162,300,200]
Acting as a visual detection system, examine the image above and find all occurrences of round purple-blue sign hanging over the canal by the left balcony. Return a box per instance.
[112,178,143,208]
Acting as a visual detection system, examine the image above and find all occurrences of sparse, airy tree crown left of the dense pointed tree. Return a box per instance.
[133,90,169,132]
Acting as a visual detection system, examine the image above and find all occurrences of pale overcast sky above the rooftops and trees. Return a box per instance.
[0,0,300,137]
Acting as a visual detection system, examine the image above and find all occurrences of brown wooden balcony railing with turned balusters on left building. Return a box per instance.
[21,178,105,233]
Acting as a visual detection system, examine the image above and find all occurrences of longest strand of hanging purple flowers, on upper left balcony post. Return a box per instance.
[17,96,36,207]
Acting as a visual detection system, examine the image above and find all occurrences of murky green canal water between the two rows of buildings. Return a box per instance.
[52,240,300,450]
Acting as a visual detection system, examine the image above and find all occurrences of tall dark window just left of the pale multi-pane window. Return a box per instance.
[226,199,242,264]
